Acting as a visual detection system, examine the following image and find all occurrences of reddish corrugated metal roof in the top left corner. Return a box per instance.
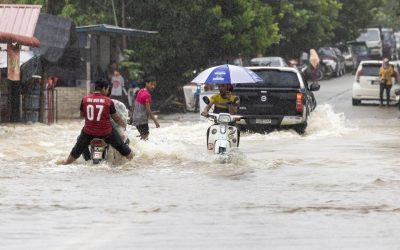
[0,4,42,36]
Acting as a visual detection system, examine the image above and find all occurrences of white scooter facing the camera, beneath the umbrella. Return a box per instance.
[203,96,241,155]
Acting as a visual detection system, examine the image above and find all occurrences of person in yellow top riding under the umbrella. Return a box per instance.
[201,84,239,117]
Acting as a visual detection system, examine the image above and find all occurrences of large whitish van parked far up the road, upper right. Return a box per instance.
[357,28,383,59]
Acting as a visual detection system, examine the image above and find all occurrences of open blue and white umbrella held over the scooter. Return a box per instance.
[192,64,263,84]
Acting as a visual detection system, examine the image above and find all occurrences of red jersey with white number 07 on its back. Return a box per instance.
[81,93,116,137]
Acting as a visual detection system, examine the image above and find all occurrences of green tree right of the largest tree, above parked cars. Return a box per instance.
[264,0,341,57]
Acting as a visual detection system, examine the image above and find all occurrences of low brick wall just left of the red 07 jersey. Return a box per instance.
[56,87,87,119]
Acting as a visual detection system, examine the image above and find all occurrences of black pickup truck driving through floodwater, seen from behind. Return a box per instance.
[234,67,320,134]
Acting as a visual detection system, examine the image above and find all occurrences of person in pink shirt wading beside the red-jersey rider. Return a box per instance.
[132,76,160,140]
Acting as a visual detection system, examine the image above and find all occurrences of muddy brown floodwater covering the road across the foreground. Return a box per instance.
[0,75,400,249]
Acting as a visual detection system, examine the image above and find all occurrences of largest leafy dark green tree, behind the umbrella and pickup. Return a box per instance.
[123,0,279,99]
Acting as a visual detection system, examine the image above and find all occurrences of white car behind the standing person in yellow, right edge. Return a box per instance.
[352,60,400,105]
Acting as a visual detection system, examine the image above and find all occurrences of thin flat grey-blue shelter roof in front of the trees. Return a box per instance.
[76,24,158,36]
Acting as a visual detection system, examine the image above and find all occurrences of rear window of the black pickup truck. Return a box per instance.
[250,70,300,88]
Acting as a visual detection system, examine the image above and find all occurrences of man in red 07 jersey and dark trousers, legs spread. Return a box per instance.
[61,80,133,165]
